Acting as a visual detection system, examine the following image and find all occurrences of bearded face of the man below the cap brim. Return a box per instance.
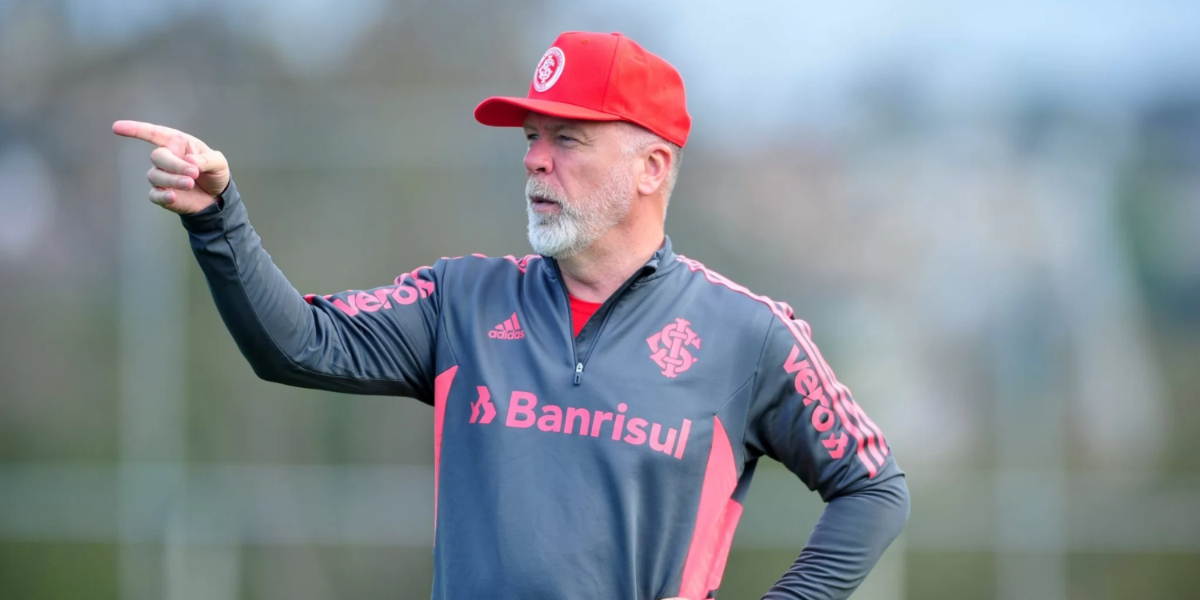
[524,113,636,258]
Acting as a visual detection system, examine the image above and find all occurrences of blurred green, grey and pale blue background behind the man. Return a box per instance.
[0,0,1200,600]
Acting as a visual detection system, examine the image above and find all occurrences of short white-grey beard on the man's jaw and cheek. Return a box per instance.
[526,168,634,258]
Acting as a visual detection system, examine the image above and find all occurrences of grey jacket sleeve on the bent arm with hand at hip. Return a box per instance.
[745,319,908,600]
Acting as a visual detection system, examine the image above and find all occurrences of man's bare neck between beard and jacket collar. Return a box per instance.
[558,211,664,302]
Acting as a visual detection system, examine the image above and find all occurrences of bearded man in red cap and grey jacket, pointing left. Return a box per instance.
[113,32,908,600]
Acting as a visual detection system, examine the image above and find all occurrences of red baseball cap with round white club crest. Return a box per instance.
[475,31,691,148]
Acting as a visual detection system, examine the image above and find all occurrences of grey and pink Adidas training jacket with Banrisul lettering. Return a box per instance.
[182,184,908,600]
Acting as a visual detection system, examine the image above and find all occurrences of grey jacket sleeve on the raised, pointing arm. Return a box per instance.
[181,177,444,404]
